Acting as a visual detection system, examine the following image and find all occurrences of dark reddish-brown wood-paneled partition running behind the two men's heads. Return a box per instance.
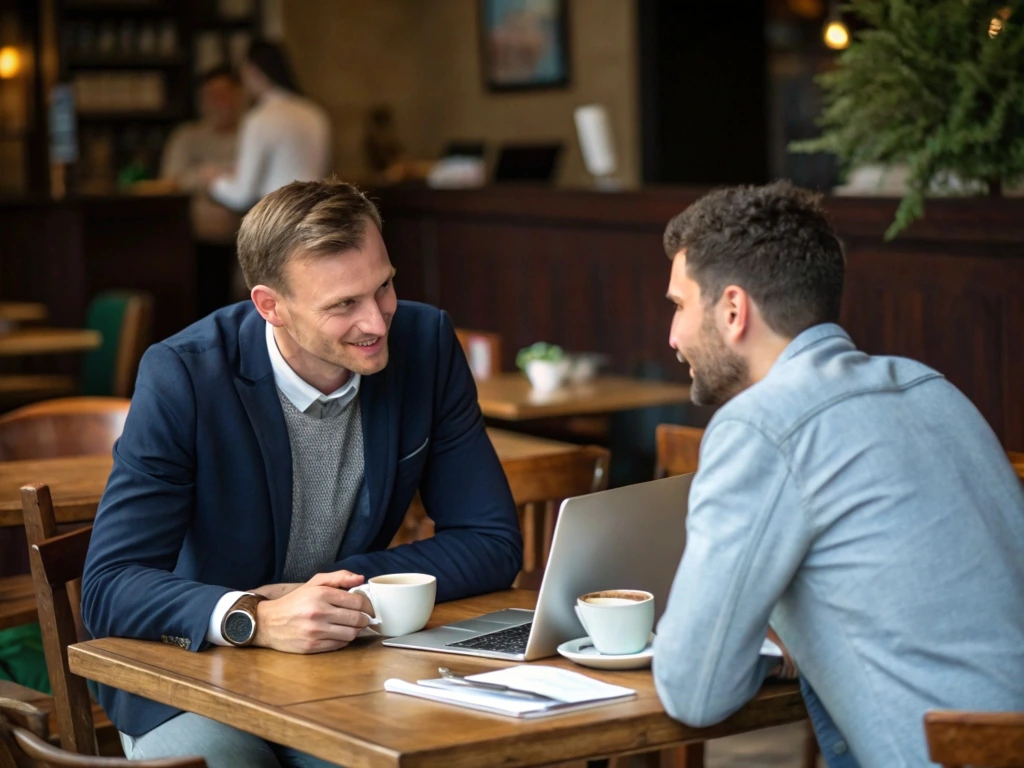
[378,187,1024,450]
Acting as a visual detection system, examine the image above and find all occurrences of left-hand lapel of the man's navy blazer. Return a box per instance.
[234,311,292,581]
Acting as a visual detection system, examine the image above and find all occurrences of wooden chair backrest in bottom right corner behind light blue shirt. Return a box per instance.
[925,712,1024,768]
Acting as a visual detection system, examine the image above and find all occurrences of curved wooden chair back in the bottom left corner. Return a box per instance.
[0,698,206,768]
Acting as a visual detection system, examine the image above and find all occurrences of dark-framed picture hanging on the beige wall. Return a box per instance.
[479,0,569,91]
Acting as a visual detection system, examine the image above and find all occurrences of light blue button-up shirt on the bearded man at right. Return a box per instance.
[654,325,1024,768]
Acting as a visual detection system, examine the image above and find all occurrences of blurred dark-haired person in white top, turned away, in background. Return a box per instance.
[205,40,331,213]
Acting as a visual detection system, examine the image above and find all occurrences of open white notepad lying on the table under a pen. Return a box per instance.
[384,664,637,718]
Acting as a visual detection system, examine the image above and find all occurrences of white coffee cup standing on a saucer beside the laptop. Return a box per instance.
[574,590,654,655]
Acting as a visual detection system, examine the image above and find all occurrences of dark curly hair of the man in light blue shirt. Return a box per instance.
[665,181,845,339]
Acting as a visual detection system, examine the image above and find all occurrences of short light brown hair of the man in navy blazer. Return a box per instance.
[238,180,381,293]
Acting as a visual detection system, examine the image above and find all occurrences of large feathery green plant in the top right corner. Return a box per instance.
[791,0,1024,240]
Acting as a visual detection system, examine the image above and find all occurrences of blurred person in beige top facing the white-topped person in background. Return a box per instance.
[160,67,244,316]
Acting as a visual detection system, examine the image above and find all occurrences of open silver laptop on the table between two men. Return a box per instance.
[384,475,693,662]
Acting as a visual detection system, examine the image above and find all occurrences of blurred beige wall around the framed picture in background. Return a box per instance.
[283,0,639,185]
